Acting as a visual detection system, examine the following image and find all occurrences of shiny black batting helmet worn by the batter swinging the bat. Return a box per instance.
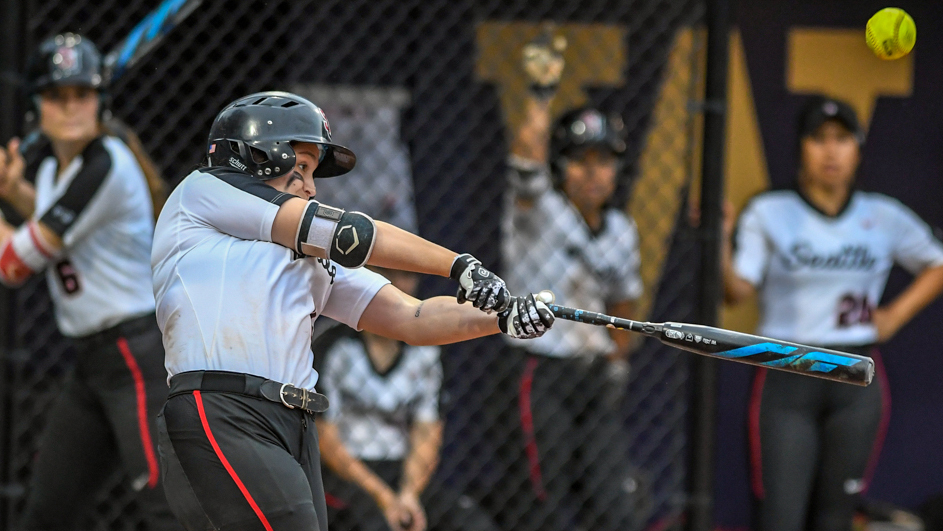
[207,91,357,181]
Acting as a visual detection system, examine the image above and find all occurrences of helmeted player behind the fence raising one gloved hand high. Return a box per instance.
[484,35,648,531]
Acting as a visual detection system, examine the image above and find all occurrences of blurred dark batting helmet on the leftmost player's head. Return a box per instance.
[26,33,104,95]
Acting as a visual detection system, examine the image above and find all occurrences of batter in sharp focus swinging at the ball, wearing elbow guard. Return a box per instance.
[151,92,553,531]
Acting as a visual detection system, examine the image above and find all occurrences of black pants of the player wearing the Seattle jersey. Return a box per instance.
[749,347,889,531]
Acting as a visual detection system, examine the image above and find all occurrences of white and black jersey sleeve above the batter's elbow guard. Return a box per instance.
[181,168,295,242]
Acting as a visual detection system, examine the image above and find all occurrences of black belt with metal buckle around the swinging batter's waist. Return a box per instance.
[170,371,328,413]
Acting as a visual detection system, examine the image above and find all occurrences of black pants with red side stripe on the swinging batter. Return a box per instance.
[158,384,327,531]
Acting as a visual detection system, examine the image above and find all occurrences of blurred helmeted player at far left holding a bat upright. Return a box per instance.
[0,33,180,530]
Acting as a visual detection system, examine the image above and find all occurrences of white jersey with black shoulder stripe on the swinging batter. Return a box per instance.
[151,168,388,389]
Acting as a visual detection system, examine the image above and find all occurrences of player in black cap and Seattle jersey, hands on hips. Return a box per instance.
[724,96,943,531]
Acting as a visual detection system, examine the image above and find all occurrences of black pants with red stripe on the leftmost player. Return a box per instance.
[20,314,180,531]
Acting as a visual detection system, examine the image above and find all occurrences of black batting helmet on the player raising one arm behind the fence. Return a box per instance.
[549,107,625,184]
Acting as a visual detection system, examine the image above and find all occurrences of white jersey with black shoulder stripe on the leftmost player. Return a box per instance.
[35,137,154,337]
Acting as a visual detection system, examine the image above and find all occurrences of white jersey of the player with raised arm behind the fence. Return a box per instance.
[502,161,642,357]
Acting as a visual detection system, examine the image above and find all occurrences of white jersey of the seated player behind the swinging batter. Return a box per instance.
[315,331,442,460]
